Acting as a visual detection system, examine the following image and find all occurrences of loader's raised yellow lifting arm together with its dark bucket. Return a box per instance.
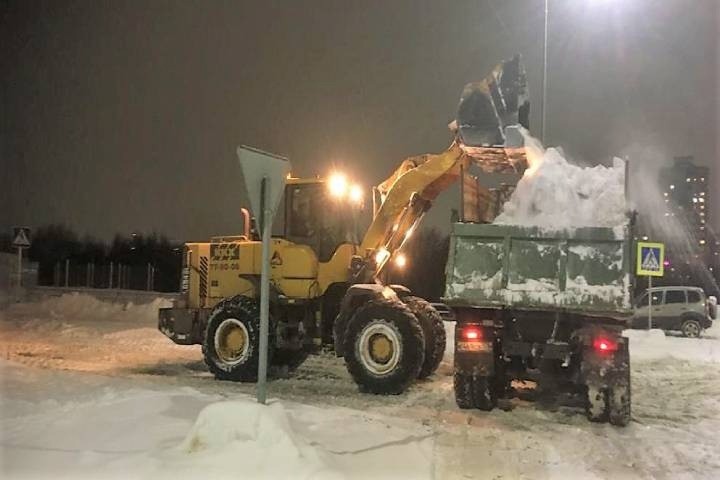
[352,56,529,283]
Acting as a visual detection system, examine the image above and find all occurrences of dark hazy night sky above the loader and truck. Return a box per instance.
[0,0,720,240]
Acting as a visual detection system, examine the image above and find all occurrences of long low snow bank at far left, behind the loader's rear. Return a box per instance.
[5,292,171,321]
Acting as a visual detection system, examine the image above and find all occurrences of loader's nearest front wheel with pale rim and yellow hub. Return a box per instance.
[343,299,425,395]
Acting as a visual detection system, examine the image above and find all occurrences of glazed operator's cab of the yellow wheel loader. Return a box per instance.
[282,178,359,262]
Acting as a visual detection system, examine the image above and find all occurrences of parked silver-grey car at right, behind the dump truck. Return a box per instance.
[632,286,712,338]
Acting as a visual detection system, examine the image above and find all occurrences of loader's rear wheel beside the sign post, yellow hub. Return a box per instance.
[202,296,273,382]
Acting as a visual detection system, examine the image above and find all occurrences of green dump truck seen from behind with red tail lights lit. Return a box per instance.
[444,223,634,426]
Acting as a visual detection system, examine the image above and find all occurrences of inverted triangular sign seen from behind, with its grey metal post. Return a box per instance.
[237,146,290,404]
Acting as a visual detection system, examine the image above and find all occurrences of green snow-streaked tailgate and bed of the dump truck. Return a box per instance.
[444,223,632,317]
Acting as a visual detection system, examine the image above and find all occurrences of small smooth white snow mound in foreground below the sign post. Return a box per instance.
[173,401,343,479]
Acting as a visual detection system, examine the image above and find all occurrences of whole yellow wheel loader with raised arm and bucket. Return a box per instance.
[159,56,529,394]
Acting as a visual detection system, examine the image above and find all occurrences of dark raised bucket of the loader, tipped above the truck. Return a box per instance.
[456,55,530,149]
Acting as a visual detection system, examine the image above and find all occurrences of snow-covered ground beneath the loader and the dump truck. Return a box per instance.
[0,296,720,479]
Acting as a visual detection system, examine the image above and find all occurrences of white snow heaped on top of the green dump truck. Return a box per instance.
[494,132,627,229]
